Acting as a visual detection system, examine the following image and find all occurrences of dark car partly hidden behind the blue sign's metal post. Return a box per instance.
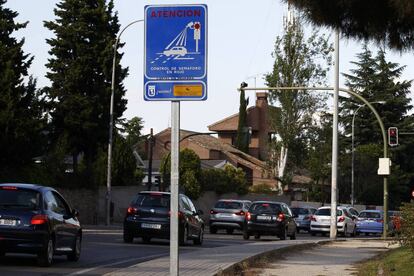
[124,191,204,245]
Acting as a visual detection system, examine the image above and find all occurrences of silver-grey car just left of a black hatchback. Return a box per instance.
[209,199,252,234]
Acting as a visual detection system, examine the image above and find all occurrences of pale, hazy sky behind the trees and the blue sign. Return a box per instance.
[5,0,414,134]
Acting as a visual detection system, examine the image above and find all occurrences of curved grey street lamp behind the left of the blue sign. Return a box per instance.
[106,19,144,225]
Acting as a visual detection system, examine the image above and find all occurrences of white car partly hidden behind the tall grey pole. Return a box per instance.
[310,206,356,237]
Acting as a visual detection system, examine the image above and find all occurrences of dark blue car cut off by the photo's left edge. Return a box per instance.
[0,183,82,266]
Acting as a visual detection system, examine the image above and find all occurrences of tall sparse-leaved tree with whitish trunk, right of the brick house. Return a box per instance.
[265,12,332,191]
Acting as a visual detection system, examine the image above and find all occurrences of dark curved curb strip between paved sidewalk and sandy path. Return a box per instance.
[214,239,334,276]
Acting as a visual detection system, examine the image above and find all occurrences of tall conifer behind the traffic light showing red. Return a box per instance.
[341,44,414,206]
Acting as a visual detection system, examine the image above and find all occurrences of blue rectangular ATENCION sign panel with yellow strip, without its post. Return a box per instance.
[144,5,207,101]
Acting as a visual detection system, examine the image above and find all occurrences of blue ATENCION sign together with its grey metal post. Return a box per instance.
[144,5,207,276]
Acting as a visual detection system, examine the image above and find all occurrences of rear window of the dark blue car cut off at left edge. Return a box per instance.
[0,186,40,209]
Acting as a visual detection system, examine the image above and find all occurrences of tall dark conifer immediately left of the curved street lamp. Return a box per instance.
[44,0,127,181]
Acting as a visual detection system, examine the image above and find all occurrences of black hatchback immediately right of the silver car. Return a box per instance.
[243,201,296,240]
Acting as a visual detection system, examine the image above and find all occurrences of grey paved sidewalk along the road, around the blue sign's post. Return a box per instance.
[105,239,326,276]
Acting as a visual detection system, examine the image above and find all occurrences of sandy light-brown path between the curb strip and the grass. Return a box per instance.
[244,239,398,276]
